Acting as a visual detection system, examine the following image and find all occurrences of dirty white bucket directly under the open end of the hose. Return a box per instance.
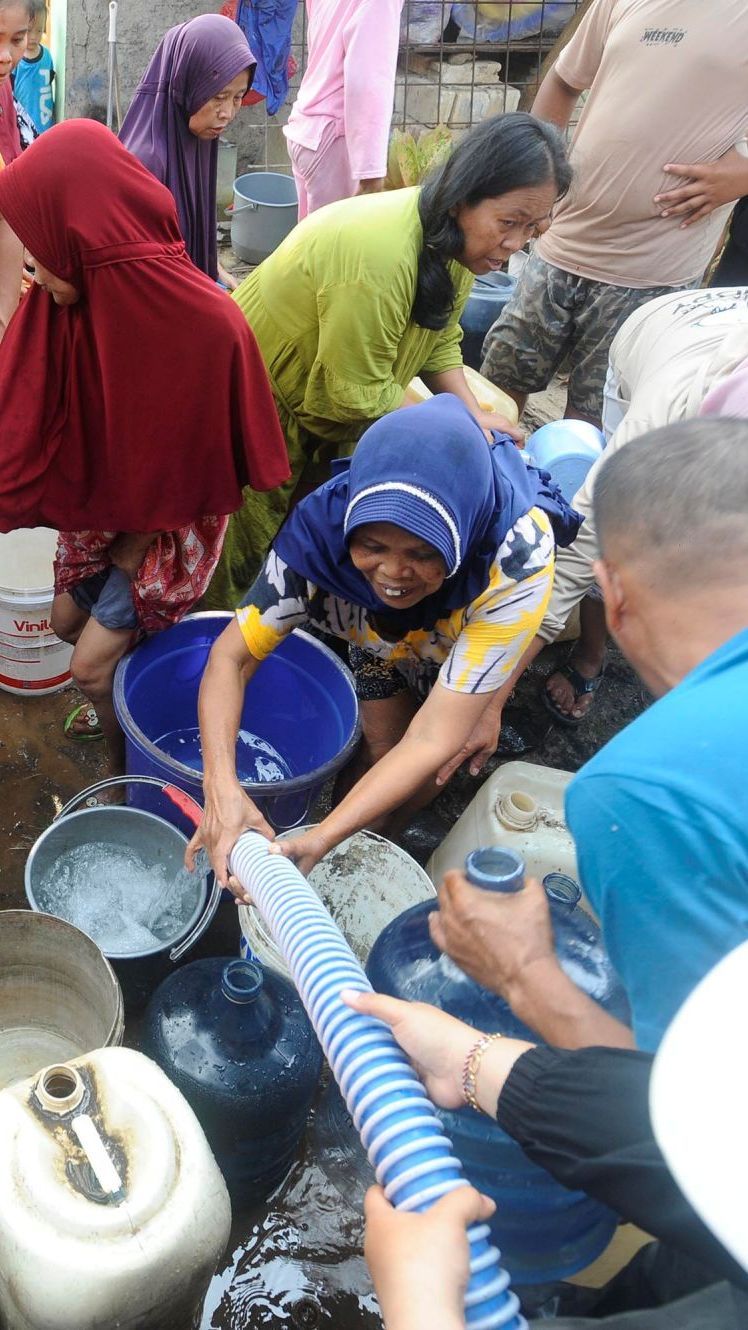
[240,826,437,979]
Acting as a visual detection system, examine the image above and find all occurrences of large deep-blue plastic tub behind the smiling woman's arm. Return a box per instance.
[114,613,359,830]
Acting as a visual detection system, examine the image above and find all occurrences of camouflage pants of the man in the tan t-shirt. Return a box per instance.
[482,254,699,423]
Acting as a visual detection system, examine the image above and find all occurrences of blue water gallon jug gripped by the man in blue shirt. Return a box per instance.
[366,847,630,1283]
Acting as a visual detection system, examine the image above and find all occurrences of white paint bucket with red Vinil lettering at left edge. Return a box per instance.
[0,527,73,694]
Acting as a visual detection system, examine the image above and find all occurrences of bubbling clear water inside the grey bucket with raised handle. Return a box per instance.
[36,841,201,956]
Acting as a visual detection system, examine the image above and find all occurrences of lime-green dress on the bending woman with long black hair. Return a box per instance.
[202,189,472,609]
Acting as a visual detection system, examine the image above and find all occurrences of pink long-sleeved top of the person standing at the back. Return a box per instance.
[285,0,403,181]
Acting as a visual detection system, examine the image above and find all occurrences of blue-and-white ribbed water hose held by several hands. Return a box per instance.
[229,831,527,1330]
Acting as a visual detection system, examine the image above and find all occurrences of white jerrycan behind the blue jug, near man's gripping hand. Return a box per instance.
[426,762,578,887]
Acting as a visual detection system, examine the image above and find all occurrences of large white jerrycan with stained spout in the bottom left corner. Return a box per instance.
[0,1048,232,1330]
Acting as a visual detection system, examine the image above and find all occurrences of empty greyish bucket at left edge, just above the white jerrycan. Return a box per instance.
[0,910,124,1089]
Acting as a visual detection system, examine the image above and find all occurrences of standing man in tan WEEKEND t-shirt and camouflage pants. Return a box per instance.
[483,0,748,424]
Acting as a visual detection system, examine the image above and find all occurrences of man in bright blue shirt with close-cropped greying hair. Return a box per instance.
[433,419,748,1049]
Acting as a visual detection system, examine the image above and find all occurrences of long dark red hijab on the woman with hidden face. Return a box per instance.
[0,120,289,532]
